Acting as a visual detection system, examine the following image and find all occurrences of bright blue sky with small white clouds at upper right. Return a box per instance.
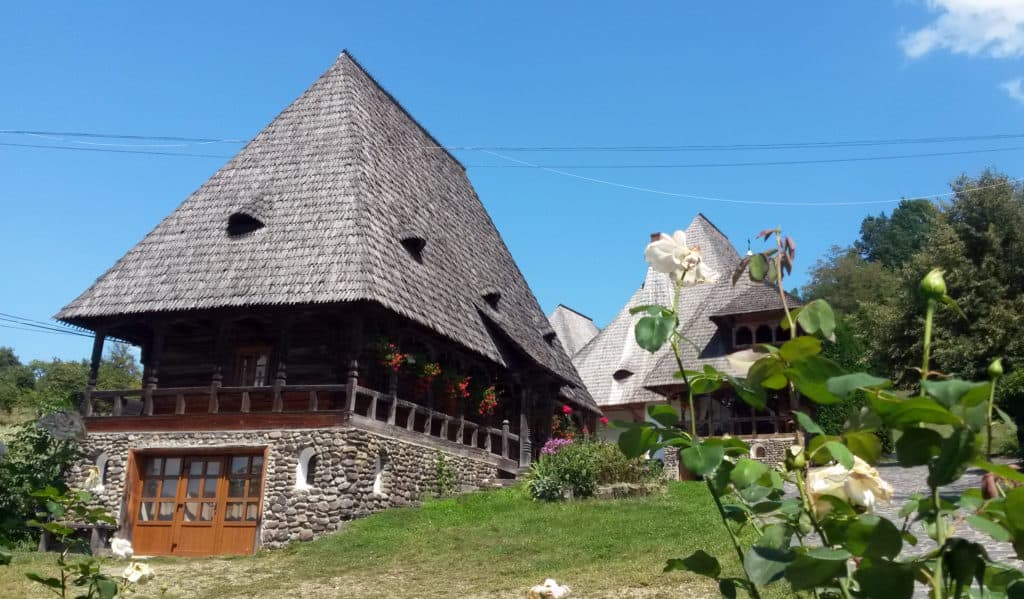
[0,0,1024,359]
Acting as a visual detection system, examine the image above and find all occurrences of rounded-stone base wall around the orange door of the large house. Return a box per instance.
[69,427,497,548]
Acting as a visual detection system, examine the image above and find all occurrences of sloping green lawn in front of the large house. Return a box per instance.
[0,482,783,599]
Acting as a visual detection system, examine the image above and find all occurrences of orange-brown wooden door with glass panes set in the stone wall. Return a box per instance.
[132,454,263,556]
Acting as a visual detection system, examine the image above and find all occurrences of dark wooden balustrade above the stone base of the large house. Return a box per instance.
[81,383,520,462]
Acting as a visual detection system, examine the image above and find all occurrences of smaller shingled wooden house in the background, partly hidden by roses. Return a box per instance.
[565,214,800,471]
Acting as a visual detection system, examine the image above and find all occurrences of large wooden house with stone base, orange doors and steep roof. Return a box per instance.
[56,53,599,556]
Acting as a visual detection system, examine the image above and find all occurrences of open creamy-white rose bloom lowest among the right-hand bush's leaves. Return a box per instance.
[807,456,893,514]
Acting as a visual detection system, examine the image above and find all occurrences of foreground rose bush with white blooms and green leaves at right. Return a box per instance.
[615,228,1024,599]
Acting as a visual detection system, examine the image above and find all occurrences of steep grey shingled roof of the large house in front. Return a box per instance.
[56,52,593,405]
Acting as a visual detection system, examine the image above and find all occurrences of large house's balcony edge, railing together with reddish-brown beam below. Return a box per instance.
[81,382,528,470]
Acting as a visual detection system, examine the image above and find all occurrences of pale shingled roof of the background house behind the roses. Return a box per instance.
[572,214,799,408]
